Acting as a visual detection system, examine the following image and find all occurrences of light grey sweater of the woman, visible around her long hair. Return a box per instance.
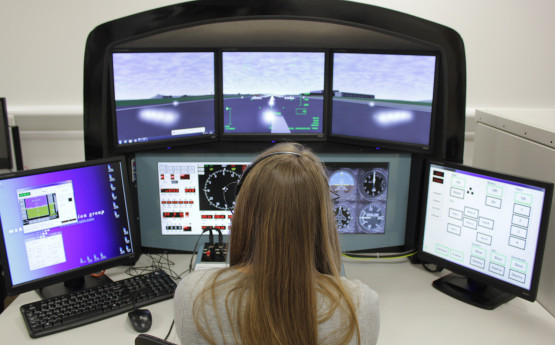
[174,270,380,345]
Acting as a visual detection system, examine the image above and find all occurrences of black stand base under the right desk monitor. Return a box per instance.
[432,273,515,310]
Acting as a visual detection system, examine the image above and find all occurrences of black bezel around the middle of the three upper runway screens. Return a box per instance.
[218,47,330,142]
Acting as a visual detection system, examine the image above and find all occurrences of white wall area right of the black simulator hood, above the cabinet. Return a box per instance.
[361,0,555,110]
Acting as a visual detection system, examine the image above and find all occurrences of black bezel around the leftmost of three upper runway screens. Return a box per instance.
[108,47,220,154]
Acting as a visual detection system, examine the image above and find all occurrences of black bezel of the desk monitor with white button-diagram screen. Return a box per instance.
[418,159,553,302]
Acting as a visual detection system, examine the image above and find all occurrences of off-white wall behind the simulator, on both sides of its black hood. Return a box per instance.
[0,0,555,168]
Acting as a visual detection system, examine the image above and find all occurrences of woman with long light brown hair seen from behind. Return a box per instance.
[174,143,379,345]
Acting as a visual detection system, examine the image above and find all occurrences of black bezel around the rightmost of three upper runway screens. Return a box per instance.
[327,49,443,156]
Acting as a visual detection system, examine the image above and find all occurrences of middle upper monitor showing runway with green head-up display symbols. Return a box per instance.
[222,51,326,140]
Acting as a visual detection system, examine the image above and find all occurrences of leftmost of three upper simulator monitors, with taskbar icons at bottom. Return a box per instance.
[112,50,216,152]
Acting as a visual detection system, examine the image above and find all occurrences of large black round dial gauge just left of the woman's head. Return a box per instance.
[203,167,241,210]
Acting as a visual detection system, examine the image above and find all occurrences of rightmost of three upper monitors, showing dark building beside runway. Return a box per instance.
[330,51,438,153]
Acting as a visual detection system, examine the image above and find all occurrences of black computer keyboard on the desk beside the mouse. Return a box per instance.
[20,270,177,338]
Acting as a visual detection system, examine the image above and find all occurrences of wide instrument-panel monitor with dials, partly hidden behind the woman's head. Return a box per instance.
[136,152,411,252]
